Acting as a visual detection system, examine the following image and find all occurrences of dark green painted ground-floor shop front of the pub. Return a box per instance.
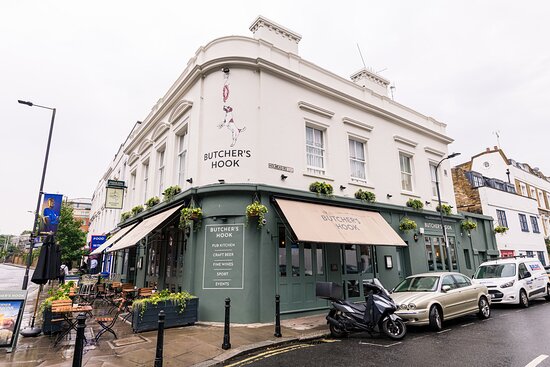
[115,185,497,323]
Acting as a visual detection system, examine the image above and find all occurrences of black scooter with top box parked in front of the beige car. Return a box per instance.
[316,279,407,340]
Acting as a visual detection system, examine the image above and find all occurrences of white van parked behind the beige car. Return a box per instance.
[472,256,550,307]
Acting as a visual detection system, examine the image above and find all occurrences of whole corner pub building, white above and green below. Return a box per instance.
[90,16,498,323]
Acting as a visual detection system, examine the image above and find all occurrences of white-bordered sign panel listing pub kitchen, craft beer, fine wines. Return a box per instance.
[202,224,244,289]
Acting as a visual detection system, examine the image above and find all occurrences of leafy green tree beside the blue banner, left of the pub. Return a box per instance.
[56,202,87,263]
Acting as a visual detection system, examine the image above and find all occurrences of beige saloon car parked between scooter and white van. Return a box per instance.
[391,272,491,331]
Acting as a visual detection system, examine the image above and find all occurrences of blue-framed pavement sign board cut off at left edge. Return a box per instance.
[0,290,27,352]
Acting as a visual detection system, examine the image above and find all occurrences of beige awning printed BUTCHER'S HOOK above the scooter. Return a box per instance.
[276,199,407,246]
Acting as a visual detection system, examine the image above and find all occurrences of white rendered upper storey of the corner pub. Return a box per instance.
[90,17,456,242]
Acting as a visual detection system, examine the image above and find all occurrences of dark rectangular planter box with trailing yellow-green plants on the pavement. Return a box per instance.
[132,289,199,333]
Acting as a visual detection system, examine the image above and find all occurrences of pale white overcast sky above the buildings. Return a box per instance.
[0,0,550,234]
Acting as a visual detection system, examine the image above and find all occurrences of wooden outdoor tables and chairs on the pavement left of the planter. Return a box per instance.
[40,274,155,347]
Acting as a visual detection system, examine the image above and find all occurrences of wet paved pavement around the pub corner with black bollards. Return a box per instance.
[0,264,329,367]
